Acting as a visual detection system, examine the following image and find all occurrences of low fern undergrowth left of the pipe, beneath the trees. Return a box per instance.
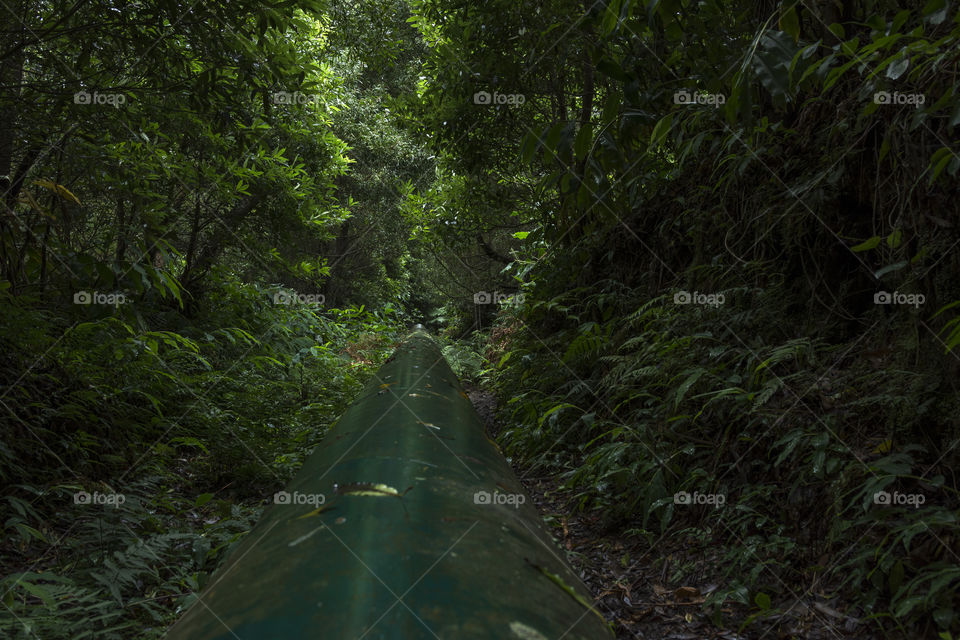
[0,279,401,640]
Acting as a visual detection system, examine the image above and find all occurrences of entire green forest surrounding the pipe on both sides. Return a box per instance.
[0,0,960,640]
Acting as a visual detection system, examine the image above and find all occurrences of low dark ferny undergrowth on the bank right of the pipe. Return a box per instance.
[491,267,960,637]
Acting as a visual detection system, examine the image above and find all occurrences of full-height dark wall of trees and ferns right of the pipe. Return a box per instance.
[417,0,960,637]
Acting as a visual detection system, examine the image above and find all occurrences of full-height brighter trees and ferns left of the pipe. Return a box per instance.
[0,2,408,638]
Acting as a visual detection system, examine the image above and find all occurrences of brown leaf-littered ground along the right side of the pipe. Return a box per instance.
[464,383,874,640]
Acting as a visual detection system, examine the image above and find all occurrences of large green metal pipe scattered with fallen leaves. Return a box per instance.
[167,327,612,640]
